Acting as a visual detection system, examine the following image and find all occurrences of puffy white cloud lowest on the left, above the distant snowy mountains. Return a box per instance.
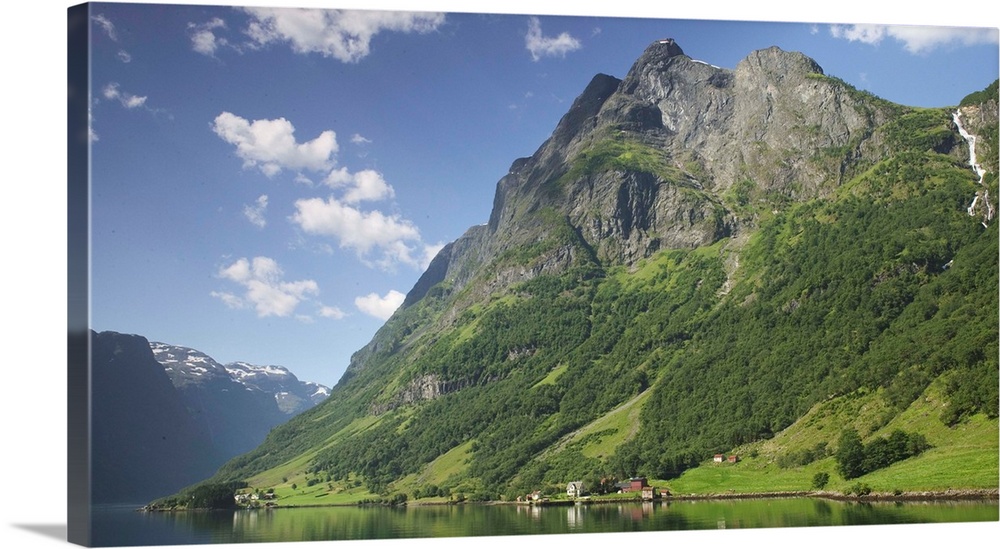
[211,257,319,317]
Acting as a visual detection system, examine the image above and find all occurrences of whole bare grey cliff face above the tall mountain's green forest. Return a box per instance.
[348,40,897,377]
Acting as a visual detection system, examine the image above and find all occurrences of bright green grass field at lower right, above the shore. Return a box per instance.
[656,376,1000,495]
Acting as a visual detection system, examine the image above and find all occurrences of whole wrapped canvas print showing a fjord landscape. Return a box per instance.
[68,2,1000,546]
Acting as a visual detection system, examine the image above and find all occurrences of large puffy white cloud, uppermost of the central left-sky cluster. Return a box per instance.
[212,112,338,177]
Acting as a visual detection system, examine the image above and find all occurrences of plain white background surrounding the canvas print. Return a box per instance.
[0,0,1000,549]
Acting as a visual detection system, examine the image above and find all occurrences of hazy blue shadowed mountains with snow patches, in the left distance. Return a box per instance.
[91,331,328,503]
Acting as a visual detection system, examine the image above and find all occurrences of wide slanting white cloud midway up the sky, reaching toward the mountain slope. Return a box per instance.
[291,197,420,268]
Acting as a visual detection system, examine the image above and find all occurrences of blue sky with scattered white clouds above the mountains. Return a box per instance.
[80,3,998,385]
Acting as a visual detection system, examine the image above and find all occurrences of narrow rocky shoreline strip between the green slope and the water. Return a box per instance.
[136,488,1000,513]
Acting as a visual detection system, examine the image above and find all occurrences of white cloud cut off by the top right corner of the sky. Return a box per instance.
[830,24,1000,54]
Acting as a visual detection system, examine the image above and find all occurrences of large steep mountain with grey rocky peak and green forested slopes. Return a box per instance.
[170,39,998,502]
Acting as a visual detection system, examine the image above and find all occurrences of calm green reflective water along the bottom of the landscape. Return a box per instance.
[93,498,1000,546]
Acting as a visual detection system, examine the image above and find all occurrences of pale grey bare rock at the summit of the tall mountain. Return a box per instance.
[600,45,885,196]
